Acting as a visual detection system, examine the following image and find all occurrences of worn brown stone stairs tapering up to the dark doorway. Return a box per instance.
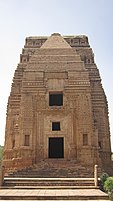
[9,160,93,178]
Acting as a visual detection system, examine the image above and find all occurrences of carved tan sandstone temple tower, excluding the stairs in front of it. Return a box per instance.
[3,33,112,176]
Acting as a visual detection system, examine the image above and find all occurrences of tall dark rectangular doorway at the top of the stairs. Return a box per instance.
[49,137,64,158]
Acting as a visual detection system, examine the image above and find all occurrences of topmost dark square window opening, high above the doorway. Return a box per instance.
[49,93,63,106]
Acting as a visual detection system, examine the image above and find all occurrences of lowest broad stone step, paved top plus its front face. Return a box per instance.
[0,189,109,200]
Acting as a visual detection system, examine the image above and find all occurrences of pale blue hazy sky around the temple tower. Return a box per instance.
[0,0,113,150]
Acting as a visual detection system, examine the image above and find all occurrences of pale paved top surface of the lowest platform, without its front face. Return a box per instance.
[0,189,106,197]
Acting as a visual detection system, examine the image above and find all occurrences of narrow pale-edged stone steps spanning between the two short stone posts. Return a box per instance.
[4,177,94,187]
